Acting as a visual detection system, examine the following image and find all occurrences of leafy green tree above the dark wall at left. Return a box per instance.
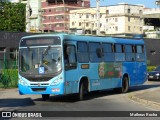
[0,1,26,32]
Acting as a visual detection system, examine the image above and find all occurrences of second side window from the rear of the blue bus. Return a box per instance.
[125,45,135,61]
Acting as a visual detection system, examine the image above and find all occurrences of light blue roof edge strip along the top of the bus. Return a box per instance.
[22,33,144,44]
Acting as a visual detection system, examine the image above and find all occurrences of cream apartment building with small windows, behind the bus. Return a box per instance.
[70,3,144,36]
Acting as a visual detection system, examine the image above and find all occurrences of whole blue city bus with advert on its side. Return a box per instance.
[18,34,146,100]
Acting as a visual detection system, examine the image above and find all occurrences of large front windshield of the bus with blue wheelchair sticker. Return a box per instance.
[19,46,62,75]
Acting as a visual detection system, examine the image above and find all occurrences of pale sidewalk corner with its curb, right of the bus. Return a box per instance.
[128,87,160,110]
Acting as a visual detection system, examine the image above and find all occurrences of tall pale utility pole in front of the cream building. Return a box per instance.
[96,0,100,35]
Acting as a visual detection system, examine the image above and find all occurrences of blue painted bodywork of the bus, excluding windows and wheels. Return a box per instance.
[18,34,146,95]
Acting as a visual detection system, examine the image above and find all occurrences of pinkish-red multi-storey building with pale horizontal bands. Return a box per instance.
[41,0,90,32]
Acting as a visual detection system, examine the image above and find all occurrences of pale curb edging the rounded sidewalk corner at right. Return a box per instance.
[127,88,160,110]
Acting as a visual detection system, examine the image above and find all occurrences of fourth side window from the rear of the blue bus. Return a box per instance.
[102,43,114,62]
